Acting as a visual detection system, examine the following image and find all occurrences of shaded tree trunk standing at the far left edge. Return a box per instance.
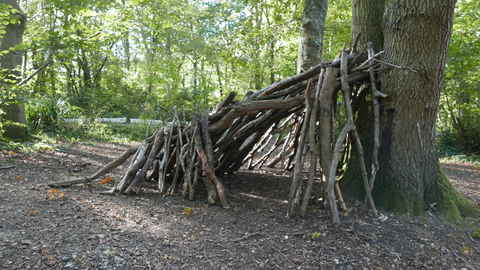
[0,0,27,139]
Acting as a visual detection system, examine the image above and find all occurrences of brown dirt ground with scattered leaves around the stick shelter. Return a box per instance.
[0,142,480,269]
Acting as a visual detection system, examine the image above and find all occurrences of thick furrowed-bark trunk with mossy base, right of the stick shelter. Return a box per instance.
[373,0,475,219]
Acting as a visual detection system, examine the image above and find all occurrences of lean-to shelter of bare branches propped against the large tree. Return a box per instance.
[50,44,385,226]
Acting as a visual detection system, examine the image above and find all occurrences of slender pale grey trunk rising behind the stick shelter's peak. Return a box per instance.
[297,0,328,74]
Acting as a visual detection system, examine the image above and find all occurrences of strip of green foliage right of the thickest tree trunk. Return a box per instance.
[438,1,480,155]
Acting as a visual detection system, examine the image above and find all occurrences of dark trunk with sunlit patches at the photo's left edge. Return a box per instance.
[0,0,27,138]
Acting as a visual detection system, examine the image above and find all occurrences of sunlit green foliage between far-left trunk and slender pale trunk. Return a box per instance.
[15,0,308,124]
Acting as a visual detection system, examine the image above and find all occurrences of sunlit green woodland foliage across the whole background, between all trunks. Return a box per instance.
[10,0,480,158]
